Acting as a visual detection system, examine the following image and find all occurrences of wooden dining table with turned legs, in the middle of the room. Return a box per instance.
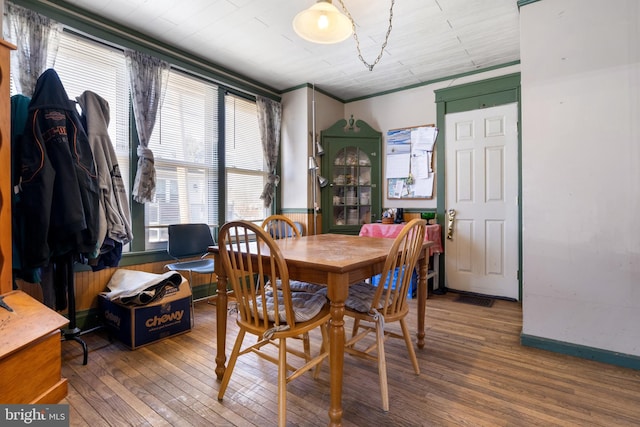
[209,234,433,426]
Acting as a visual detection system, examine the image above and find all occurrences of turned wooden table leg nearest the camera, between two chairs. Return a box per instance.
[327,274,349,426]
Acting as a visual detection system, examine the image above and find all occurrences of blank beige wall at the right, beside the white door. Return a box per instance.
[520,0,640,356]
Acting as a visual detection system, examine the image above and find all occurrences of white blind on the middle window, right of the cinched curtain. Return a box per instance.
[145,70,220,249]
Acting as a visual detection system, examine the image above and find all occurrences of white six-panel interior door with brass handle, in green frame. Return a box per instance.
[444,103,518,299]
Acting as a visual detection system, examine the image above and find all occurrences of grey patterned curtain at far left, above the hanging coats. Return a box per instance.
[5,2,61,97]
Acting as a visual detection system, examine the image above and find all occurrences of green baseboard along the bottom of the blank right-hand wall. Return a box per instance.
[520,334,640,369]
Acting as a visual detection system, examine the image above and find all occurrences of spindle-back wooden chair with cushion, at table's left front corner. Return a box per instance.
[218,221,330,426]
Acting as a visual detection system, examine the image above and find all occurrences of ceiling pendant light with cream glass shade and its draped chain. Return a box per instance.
[293,0,395,71]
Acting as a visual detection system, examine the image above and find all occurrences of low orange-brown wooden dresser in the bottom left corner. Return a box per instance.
[0,291,69,404]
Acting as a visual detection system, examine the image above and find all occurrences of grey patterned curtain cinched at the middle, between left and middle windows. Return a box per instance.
[125,49,169,203]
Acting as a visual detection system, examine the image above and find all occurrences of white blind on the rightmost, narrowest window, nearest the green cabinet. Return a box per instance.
[225,94,269,221]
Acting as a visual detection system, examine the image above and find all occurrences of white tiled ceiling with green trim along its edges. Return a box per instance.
[60,0,520,101]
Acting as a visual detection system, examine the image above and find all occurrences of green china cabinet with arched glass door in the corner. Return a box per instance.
[320,116,382,234]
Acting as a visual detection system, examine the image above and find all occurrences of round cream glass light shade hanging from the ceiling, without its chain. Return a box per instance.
[293,0,353,44]
